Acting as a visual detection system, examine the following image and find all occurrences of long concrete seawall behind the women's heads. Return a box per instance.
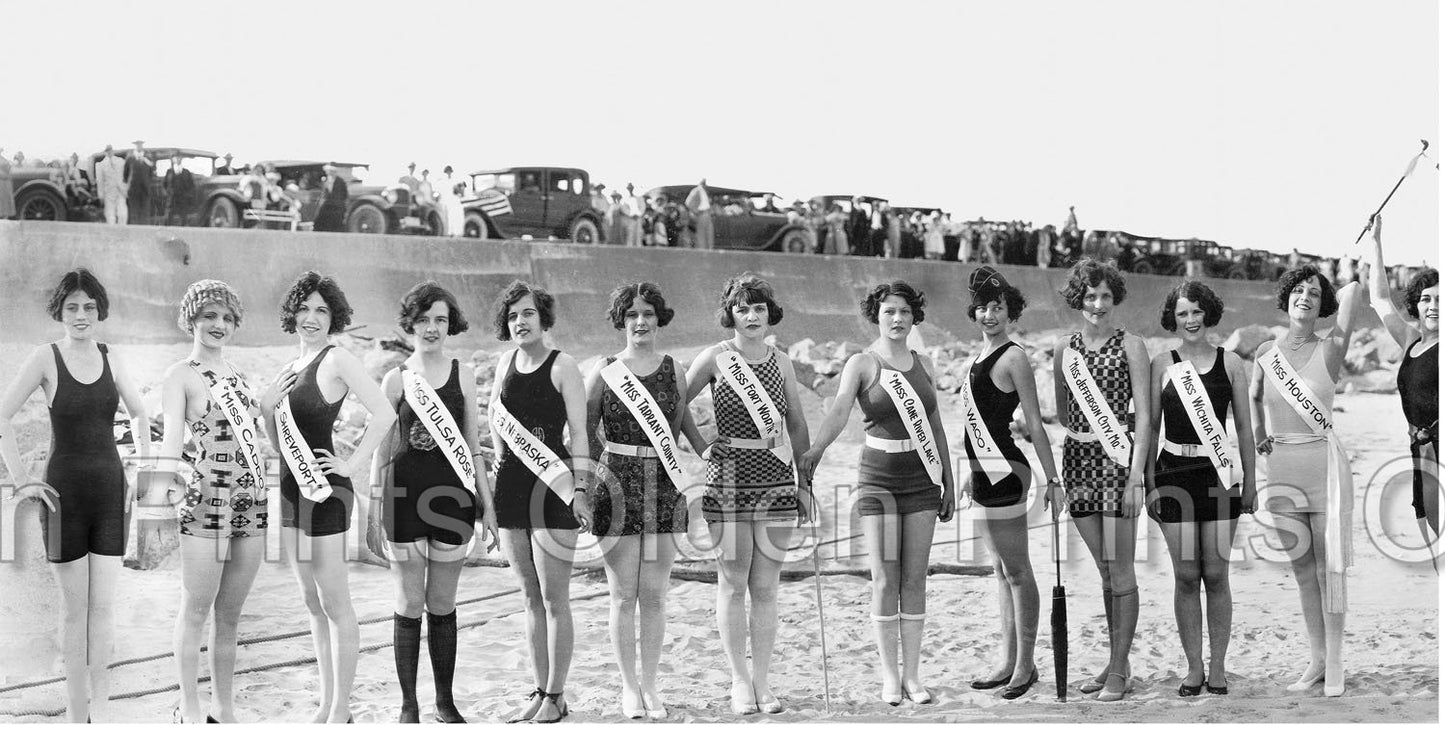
[0,221,1358,350]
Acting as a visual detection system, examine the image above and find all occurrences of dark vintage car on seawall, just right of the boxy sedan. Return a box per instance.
[646,184,812,253]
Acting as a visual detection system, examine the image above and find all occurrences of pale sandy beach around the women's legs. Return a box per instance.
[0,346,1439,723]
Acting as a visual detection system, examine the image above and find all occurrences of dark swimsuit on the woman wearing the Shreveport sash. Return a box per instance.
[280,344,355,537]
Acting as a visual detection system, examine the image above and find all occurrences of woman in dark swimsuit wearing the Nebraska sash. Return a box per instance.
[487,281,591,723]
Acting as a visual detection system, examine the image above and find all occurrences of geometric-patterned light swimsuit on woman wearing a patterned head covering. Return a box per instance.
[176,362,267,540]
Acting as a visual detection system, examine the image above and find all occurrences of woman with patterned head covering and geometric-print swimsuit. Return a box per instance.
[160,279,278,723]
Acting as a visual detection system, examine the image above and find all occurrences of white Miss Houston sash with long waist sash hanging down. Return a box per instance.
[1259,344,1354,613]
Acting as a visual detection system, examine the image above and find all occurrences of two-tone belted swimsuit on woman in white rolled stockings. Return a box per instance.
[854,350,944,515]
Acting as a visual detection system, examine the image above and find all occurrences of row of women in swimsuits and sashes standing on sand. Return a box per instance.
[0,250,1438,722]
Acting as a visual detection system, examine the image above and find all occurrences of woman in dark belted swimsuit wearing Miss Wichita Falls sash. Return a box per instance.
[1147,281,1256,696]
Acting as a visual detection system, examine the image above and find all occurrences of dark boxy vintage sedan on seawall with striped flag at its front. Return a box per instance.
[462,166,604,243]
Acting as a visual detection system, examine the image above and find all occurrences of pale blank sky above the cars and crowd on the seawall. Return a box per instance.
[0,0,1441,265]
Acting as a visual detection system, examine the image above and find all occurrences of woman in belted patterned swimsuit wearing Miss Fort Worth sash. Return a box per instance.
[683,273,812,715]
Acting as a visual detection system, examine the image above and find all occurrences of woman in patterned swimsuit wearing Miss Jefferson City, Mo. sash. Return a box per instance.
[1053,259,1149,702]
